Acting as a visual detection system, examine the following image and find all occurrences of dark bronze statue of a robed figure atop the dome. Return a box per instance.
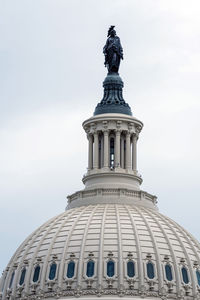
[103,26,123,73]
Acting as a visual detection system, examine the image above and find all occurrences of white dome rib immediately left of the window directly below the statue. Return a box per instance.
[98,204,108,290]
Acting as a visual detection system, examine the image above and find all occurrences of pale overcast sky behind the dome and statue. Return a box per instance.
[0,0,200,272]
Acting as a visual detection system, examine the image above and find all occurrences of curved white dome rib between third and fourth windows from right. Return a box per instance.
[135,207,163,290]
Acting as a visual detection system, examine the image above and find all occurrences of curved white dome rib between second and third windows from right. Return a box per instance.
[144,209,181,293]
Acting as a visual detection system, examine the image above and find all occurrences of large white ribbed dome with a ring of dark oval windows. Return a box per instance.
[2,204,200,299]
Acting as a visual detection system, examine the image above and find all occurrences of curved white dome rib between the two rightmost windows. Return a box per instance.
[156,214,196,295]
